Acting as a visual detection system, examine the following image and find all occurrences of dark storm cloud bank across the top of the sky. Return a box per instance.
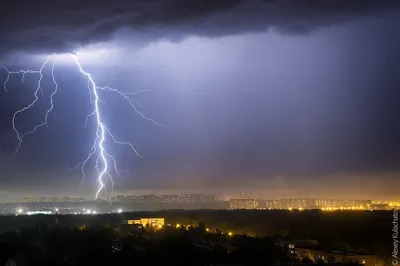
[0,0,400,53]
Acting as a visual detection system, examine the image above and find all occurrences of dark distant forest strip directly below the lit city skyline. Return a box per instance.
[0,210,392,256]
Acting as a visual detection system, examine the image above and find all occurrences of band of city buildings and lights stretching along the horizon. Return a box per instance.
[0,194,400,215]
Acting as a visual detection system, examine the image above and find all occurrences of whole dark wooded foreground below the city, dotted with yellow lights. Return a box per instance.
[0,211,392,266]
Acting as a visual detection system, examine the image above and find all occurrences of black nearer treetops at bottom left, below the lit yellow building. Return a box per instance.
[0,225,290,266]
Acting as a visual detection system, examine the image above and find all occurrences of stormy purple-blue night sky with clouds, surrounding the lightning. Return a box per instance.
[0,0,400,200]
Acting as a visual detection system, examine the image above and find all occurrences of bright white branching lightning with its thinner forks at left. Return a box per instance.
[1,54,163,199]
